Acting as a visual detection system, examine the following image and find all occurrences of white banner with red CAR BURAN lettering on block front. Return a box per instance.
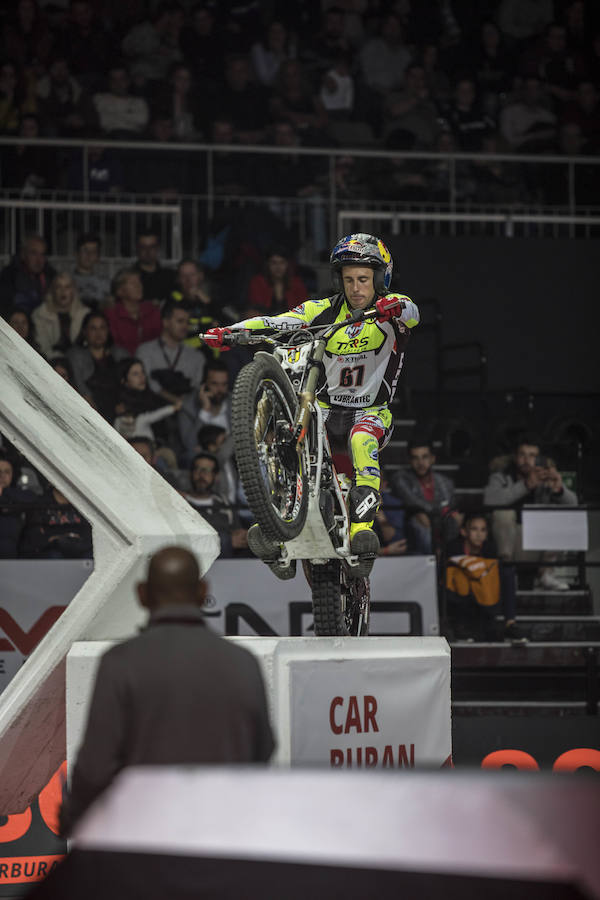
[289,639,451,769]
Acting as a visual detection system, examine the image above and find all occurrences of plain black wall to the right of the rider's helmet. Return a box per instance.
[388,235,600,393]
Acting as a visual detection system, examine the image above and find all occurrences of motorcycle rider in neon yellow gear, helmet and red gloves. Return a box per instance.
[206,233,419,578]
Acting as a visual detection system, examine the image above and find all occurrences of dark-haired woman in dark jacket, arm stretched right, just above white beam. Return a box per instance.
[113,357,181,441]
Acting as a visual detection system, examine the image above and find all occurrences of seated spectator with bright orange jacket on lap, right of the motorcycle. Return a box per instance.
[445,513,527,644]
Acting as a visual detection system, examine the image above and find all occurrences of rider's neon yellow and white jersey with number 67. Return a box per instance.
[232,294,419,409]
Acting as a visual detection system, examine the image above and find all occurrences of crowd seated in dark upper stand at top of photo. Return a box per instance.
[0,0,600,203]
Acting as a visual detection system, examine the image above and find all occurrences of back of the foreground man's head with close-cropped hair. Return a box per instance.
[138,547,206,612]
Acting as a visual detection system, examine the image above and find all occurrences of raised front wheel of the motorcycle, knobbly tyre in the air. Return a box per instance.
[232,355,308,542]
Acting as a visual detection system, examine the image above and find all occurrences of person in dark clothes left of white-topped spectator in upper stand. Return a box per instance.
[37,56,96,137]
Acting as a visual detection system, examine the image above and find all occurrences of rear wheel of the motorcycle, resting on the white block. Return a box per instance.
[304,559,371,637]
